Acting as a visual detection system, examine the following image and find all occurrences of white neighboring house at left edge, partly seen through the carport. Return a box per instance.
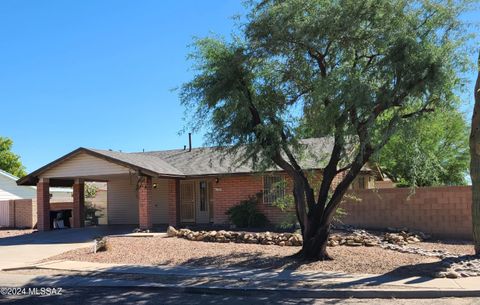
[0,169,72,201]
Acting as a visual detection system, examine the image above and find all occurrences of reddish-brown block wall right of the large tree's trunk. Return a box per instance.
[342,186,472,239]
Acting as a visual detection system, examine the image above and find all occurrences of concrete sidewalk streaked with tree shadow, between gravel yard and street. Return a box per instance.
[5,261,480,297]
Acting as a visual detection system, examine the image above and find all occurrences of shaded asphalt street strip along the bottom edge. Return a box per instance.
[0,287,480,305]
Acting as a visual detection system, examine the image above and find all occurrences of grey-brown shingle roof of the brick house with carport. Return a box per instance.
[17,138,371,186]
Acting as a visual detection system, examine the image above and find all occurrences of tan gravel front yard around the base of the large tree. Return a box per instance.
[50,237,473,275]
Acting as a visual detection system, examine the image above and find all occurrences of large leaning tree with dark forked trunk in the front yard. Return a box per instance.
[181,0,465,260]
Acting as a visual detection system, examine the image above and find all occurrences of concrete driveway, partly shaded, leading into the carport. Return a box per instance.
[0,226,133,269]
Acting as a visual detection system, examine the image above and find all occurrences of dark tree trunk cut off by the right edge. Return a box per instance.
[470,54,480,255]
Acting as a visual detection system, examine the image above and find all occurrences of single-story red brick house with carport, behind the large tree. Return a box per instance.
[17,139,381,230]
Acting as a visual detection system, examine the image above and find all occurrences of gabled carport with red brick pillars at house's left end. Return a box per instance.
[17,148,184,231]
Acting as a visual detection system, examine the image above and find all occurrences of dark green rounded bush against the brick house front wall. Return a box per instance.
[226,196,268,228]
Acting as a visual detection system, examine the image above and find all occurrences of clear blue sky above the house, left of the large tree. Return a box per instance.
[0,0,480,171]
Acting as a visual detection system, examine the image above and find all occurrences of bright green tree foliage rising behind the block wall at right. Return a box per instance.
[374,109,470,187]
